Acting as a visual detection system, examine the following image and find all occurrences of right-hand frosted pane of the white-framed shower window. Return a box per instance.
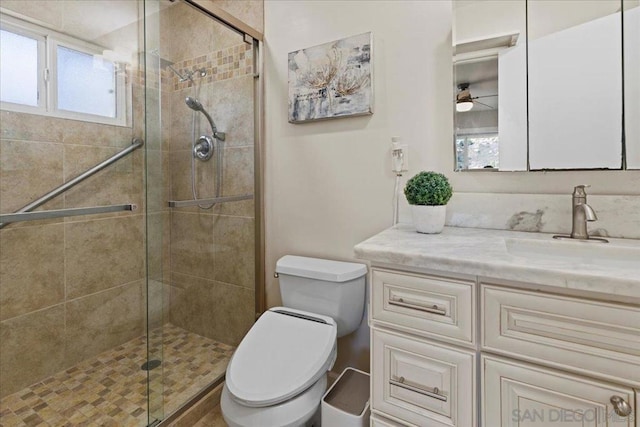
[58,46,116,117]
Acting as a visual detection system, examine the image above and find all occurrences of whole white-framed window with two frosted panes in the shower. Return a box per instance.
[0,15,130,126]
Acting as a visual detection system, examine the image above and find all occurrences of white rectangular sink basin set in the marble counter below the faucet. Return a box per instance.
[505,237,640,270]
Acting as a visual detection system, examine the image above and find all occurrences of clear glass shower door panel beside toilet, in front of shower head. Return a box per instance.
[144,0,262,418]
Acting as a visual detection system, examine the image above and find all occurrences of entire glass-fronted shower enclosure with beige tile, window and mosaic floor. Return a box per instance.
[0,0,263,426]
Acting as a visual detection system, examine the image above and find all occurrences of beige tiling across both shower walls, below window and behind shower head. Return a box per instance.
[0,0,262,402]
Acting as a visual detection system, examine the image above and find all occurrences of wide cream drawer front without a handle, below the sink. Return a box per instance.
[481,284,640,386]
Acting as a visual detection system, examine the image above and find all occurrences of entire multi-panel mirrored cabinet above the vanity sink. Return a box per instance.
[453,0,640,171]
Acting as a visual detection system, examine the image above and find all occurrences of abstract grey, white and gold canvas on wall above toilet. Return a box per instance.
[289,32,373,123]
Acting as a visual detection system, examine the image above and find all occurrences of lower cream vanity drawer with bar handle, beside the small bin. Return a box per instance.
[371,328,476,427]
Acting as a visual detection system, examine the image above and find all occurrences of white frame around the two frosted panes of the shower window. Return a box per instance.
[0,10,132,126]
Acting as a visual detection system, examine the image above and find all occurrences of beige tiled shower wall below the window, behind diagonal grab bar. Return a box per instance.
[0,84,146,402]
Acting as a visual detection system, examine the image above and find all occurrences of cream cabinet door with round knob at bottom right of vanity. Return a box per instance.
[482,355,636,427]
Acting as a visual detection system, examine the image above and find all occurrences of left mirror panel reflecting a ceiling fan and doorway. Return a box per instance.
[453,0,527,171]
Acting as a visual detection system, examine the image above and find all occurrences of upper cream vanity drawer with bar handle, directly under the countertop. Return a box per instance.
[371,269,476,346]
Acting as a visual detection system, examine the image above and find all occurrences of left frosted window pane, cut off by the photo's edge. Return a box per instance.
[0,30,38,106]
